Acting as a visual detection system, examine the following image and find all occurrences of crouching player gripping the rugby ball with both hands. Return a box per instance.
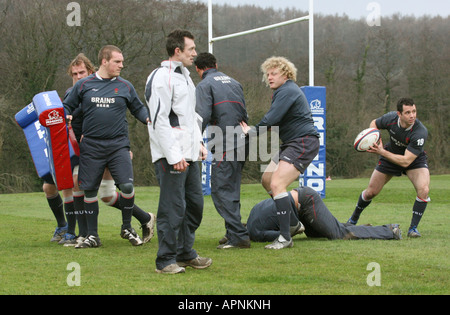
[348,98,430,237]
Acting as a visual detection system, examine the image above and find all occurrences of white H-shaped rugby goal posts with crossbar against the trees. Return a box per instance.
[208,0,314,86]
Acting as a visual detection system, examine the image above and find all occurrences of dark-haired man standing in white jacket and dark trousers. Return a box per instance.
[145,30,212,274]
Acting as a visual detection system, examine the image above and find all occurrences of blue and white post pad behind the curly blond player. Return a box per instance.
[300,86,327,198]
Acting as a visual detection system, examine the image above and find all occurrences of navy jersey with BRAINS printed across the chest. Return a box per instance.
[63,73,150,139]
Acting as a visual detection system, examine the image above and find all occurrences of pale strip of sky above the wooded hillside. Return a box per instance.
[200,0,450,19]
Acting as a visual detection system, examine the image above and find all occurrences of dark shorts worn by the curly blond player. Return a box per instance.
[272,136,320,174]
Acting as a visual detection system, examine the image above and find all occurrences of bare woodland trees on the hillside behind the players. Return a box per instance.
[0,0,450,193]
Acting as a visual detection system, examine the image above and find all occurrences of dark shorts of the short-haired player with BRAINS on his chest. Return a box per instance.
[78,137,134,190]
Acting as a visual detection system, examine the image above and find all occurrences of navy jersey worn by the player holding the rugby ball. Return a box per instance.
[375,111,428,155]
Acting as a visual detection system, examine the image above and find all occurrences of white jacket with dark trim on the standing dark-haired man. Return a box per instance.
[145,60,203,165]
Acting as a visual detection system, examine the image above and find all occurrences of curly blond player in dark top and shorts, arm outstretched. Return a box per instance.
[241,57,320,249]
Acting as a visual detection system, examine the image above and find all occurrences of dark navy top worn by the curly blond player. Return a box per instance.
[251,80,320,142]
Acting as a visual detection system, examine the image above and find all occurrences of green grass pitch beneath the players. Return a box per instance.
[0,175,450,295]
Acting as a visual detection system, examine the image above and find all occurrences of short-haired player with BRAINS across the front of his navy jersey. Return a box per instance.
[63,45,149,248]
